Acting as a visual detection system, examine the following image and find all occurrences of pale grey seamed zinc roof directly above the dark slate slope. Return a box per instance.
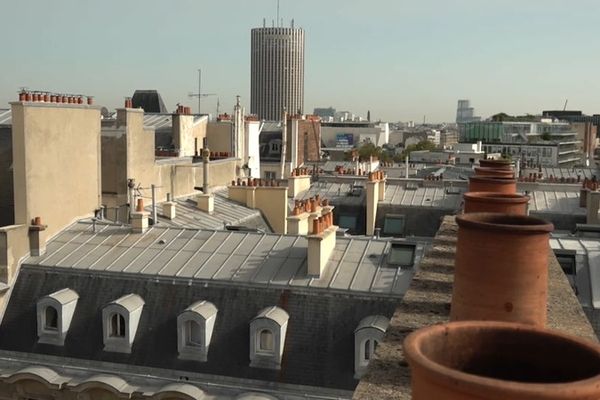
[23,222,423,298]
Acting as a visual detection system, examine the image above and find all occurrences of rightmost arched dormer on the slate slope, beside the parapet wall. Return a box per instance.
[354,315,390,379]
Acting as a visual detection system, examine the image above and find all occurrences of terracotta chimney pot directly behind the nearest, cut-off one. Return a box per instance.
[450,213,554,326]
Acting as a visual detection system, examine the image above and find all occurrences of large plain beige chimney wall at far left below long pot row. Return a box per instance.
[11,103,101,241]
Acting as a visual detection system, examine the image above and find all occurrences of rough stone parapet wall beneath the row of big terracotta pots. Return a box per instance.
[353,216,597,400]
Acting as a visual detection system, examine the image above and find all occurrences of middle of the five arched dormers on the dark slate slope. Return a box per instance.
[177,301,217,362]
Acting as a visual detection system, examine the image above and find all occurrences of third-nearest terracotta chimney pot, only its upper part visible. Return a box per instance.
[464,192,529,215]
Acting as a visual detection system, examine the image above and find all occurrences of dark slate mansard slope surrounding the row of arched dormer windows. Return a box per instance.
[0,265,400,390]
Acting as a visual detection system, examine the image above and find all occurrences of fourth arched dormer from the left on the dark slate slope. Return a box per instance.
[250,306,290,369]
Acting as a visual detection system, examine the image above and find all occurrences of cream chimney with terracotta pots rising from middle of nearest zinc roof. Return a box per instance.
[307,211,337,277]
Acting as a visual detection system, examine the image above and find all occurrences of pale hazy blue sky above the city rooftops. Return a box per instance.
[0,0,600,122]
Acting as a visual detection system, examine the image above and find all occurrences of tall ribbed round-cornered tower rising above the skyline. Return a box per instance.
[250,21,304,121]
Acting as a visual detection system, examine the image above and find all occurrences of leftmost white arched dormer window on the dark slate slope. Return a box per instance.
[36,289,79,346]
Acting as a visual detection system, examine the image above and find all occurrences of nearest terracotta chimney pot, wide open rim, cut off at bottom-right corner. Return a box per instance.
[403,321,600,400]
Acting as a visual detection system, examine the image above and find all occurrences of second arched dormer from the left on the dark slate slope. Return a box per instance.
[102,294,144,353]
